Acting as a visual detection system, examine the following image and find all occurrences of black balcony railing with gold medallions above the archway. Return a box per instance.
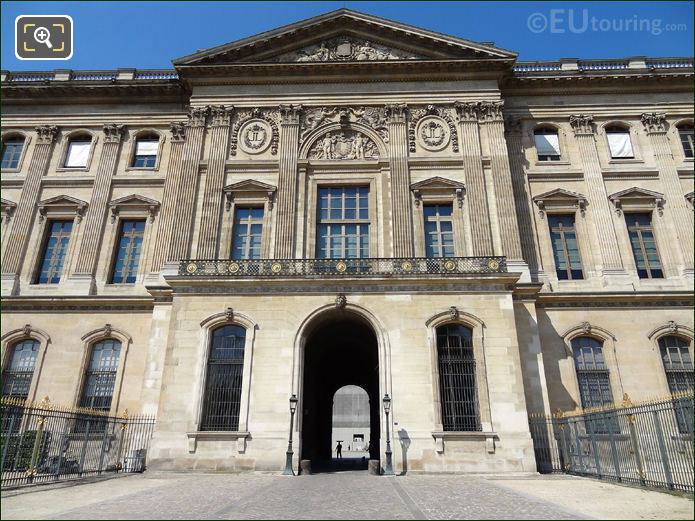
[179,257,507,278]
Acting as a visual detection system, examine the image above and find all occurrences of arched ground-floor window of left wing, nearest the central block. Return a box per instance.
[79,338,121,412]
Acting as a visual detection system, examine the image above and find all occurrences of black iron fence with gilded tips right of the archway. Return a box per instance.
[529,390,693,492]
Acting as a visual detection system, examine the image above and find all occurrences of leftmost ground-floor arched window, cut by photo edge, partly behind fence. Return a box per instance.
[2,338,39,433]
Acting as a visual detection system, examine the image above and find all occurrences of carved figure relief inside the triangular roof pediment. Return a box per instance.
[273,37,420,62]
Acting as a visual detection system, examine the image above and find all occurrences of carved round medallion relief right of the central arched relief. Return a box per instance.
[408,105,459,153]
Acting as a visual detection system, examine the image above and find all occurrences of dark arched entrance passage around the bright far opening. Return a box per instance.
[301,309,381,469]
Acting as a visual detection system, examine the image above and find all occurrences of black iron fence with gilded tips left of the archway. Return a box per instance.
[0,397,155,488]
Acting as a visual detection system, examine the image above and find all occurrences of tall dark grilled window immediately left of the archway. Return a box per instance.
[200,325,246,431]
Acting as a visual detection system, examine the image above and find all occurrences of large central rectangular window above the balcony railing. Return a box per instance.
[316,186,369,259]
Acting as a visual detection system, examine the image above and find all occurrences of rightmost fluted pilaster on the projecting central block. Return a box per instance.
[479,101,523,261]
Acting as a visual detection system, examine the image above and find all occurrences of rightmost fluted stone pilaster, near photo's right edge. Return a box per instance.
[642,113,693,273]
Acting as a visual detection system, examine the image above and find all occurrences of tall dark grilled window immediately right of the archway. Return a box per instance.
[437,324,481,431]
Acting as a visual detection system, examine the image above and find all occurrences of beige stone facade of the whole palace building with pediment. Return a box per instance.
[2,10,693,472]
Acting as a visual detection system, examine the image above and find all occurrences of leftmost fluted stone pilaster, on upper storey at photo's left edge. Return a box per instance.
[2,126,58,277]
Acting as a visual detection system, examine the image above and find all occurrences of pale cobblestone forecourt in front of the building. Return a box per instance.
[2,472,693,519]
